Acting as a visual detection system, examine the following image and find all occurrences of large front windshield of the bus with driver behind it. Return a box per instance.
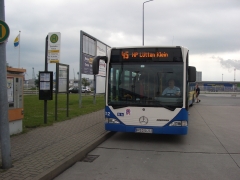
[107,62,183,110]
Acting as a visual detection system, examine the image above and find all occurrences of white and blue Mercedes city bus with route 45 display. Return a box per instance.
[92,46,196,135]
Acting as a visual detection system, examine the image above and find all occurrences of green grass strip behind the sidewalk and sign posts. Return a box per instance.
[23,94,105,129]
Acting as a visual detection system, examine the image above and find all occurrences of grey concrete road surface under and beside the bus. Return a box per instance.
[55,94,240,180]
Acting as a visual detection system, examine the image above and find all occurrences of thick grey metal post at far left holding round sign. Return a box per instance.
[0,0,12,169]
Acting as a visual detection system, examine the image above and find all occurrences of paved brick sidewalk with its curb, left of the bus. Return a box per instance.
[0,110,112,180]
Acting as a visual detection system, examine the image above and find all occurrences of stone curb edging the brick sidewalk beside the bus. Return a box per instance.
[34,132,114,180]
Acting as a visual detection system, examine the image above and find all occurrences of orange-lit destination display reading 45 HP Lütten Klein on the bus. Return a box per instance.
[111,47,183,62]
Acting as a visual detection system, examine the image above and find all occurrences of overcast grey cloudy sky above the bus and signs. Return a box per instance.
[5,0,240,81]
